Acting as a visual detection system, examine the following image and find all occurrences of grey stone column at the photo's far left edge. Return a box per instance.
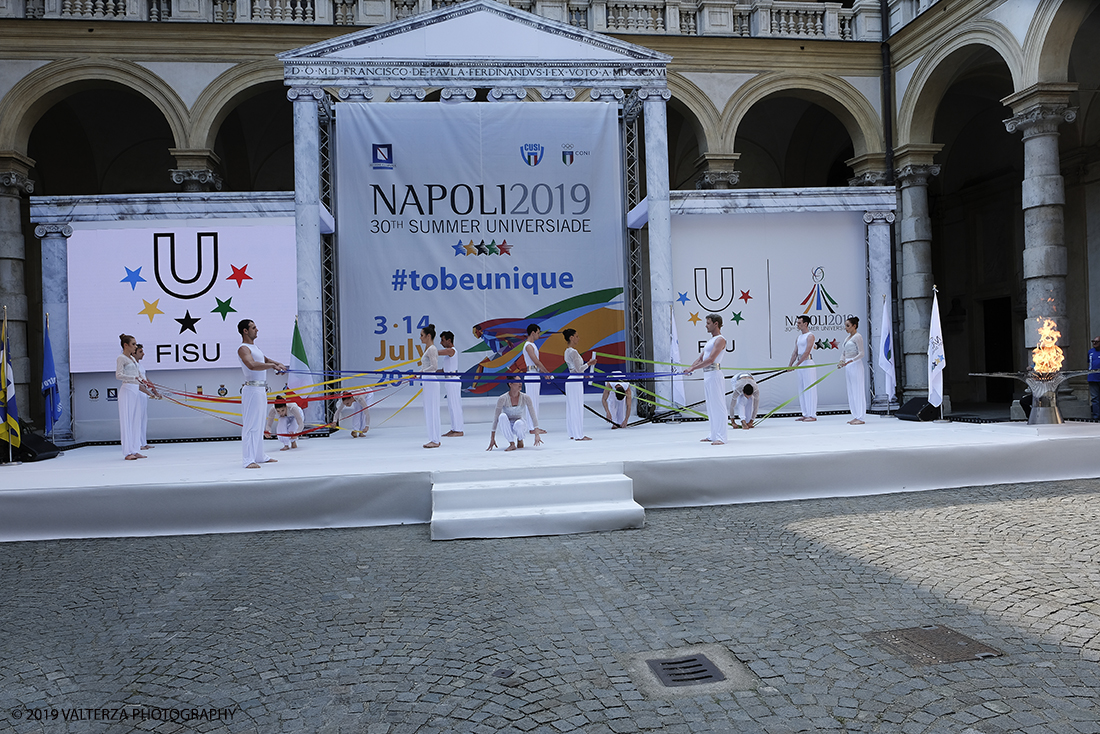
[0,151,34,420]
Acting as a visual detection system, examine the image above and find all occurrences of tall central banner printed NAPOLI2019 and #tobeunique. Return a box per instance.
[336,102,625,395]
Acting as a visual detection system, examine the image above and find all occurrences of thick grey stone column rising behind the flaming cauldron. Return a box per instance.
[1001,84,1077,349]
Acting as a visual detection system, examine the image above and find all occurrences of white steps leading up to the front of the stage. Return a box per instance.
[431,463,646,540]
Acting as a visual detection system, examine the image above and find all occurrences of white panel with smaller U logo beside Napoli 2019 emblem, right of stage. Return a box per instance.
[672,211,870,414]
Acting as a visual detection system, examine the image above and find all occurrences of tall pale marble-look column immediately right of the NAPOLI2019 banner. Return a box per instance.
[638,89,672,404]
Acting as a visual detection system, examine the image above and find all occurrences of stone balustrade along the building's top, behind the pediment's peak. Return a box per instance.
[0,0,880,41]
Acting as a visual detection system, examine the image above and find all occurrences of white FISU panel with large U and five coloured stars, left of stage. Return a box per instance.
[68,218,298,374]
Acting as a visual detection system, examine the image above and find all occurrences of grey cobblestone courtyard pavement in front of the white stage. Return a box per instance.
[0,481,1100,734]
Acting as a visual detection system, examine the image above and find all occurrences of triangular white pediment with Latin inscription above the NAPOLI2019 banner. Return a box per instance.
[278,0,671,89]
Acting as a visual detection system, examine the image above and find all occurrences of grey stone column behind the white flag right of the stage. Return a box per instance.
[895,145,943,401]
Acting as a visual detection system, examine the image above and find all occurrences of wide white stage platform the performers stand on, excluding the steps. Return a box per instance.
[0,415,1100,541]
